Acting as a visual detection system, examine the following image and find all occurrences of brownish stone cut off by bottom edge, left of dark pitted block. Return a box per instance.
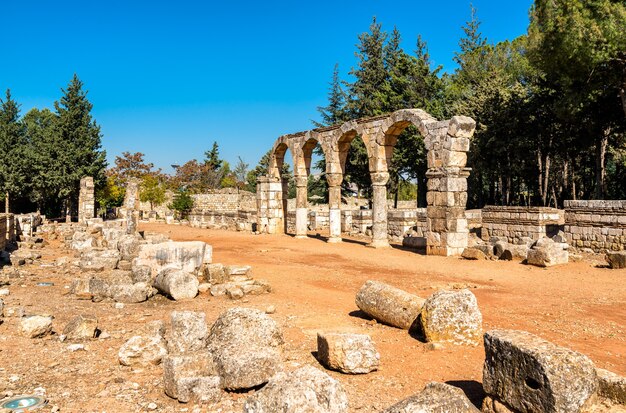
[383,382,480,413]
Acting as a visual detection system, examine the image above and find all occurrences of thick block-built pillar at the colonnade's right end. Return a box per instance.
[426,116,476,256]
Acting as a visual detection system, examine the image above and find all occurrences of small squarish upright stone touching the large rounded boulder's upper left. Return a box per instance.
[167,311,209,354]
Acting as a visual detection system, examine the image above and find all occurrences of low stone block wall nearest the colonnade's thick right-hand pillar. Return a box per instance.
[480,206,565,242]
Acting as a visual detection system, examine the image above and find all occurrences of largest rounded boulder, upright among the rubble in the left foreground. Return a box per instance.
[208,307,284,390]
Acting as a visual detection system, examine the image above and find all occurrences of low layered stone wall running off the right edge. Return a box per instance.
[564,201,626,252]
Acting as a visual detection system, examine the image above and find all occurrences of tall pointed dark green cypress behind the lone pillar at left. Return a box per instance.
[54,74,106,216]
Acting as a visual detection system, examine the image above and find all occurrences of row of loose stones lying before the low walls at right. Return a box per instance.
[462,232,569,267]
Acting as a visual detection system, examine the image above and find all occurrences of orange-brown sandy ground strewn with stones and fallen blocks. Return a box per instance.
[0,224,626,412]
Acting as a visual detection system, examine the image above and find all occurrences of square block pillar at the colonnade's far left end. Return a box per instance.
[256,176,284,234]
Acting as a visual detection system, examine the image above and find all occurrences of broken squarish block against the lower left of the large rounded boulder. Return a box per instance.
[161,351,216,399]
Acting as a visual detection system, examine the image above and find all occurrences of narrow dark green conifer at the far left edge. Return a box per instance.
[0,90,26,212]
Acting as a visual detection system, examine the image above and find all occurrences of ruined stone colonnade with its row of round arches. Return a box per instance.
[257,109,476,255]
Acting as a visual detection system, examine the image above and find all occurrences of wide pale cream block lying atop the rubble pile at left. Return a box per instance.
[133,241,212,277]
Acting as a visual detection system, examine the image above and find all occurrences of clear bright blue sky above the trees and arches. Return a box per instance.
[0,0,532,172]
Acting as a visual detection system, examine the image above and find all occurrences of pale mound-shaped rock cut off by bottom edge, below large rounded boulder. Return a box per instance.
[243,366,348,413]
